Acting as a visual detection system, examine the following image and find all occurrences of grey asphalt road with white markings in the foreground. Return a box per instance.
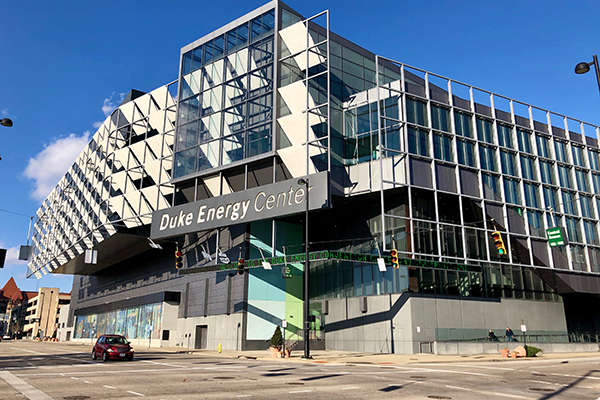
[0,341,600,400]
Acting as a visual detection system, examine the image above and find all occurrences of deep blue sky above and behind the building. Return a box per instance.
[0,0,600,292]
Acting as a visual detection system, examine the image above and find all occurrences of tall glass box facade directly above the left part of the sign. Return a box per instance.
[173,10,275,178]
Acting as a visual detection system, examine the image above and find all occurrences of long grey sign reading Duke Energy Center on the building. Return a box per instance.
[150,172,329,239]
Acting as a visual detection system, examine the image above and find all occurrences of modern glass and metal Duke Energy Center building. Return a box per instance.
[29,1,600,353]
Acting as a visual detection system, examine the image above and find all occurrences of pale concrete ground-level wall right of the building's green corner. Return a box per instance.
[324,293,567,354]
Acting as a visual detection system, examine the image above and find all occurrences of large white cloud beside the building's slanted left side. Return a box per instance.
[24,131,90,201]
